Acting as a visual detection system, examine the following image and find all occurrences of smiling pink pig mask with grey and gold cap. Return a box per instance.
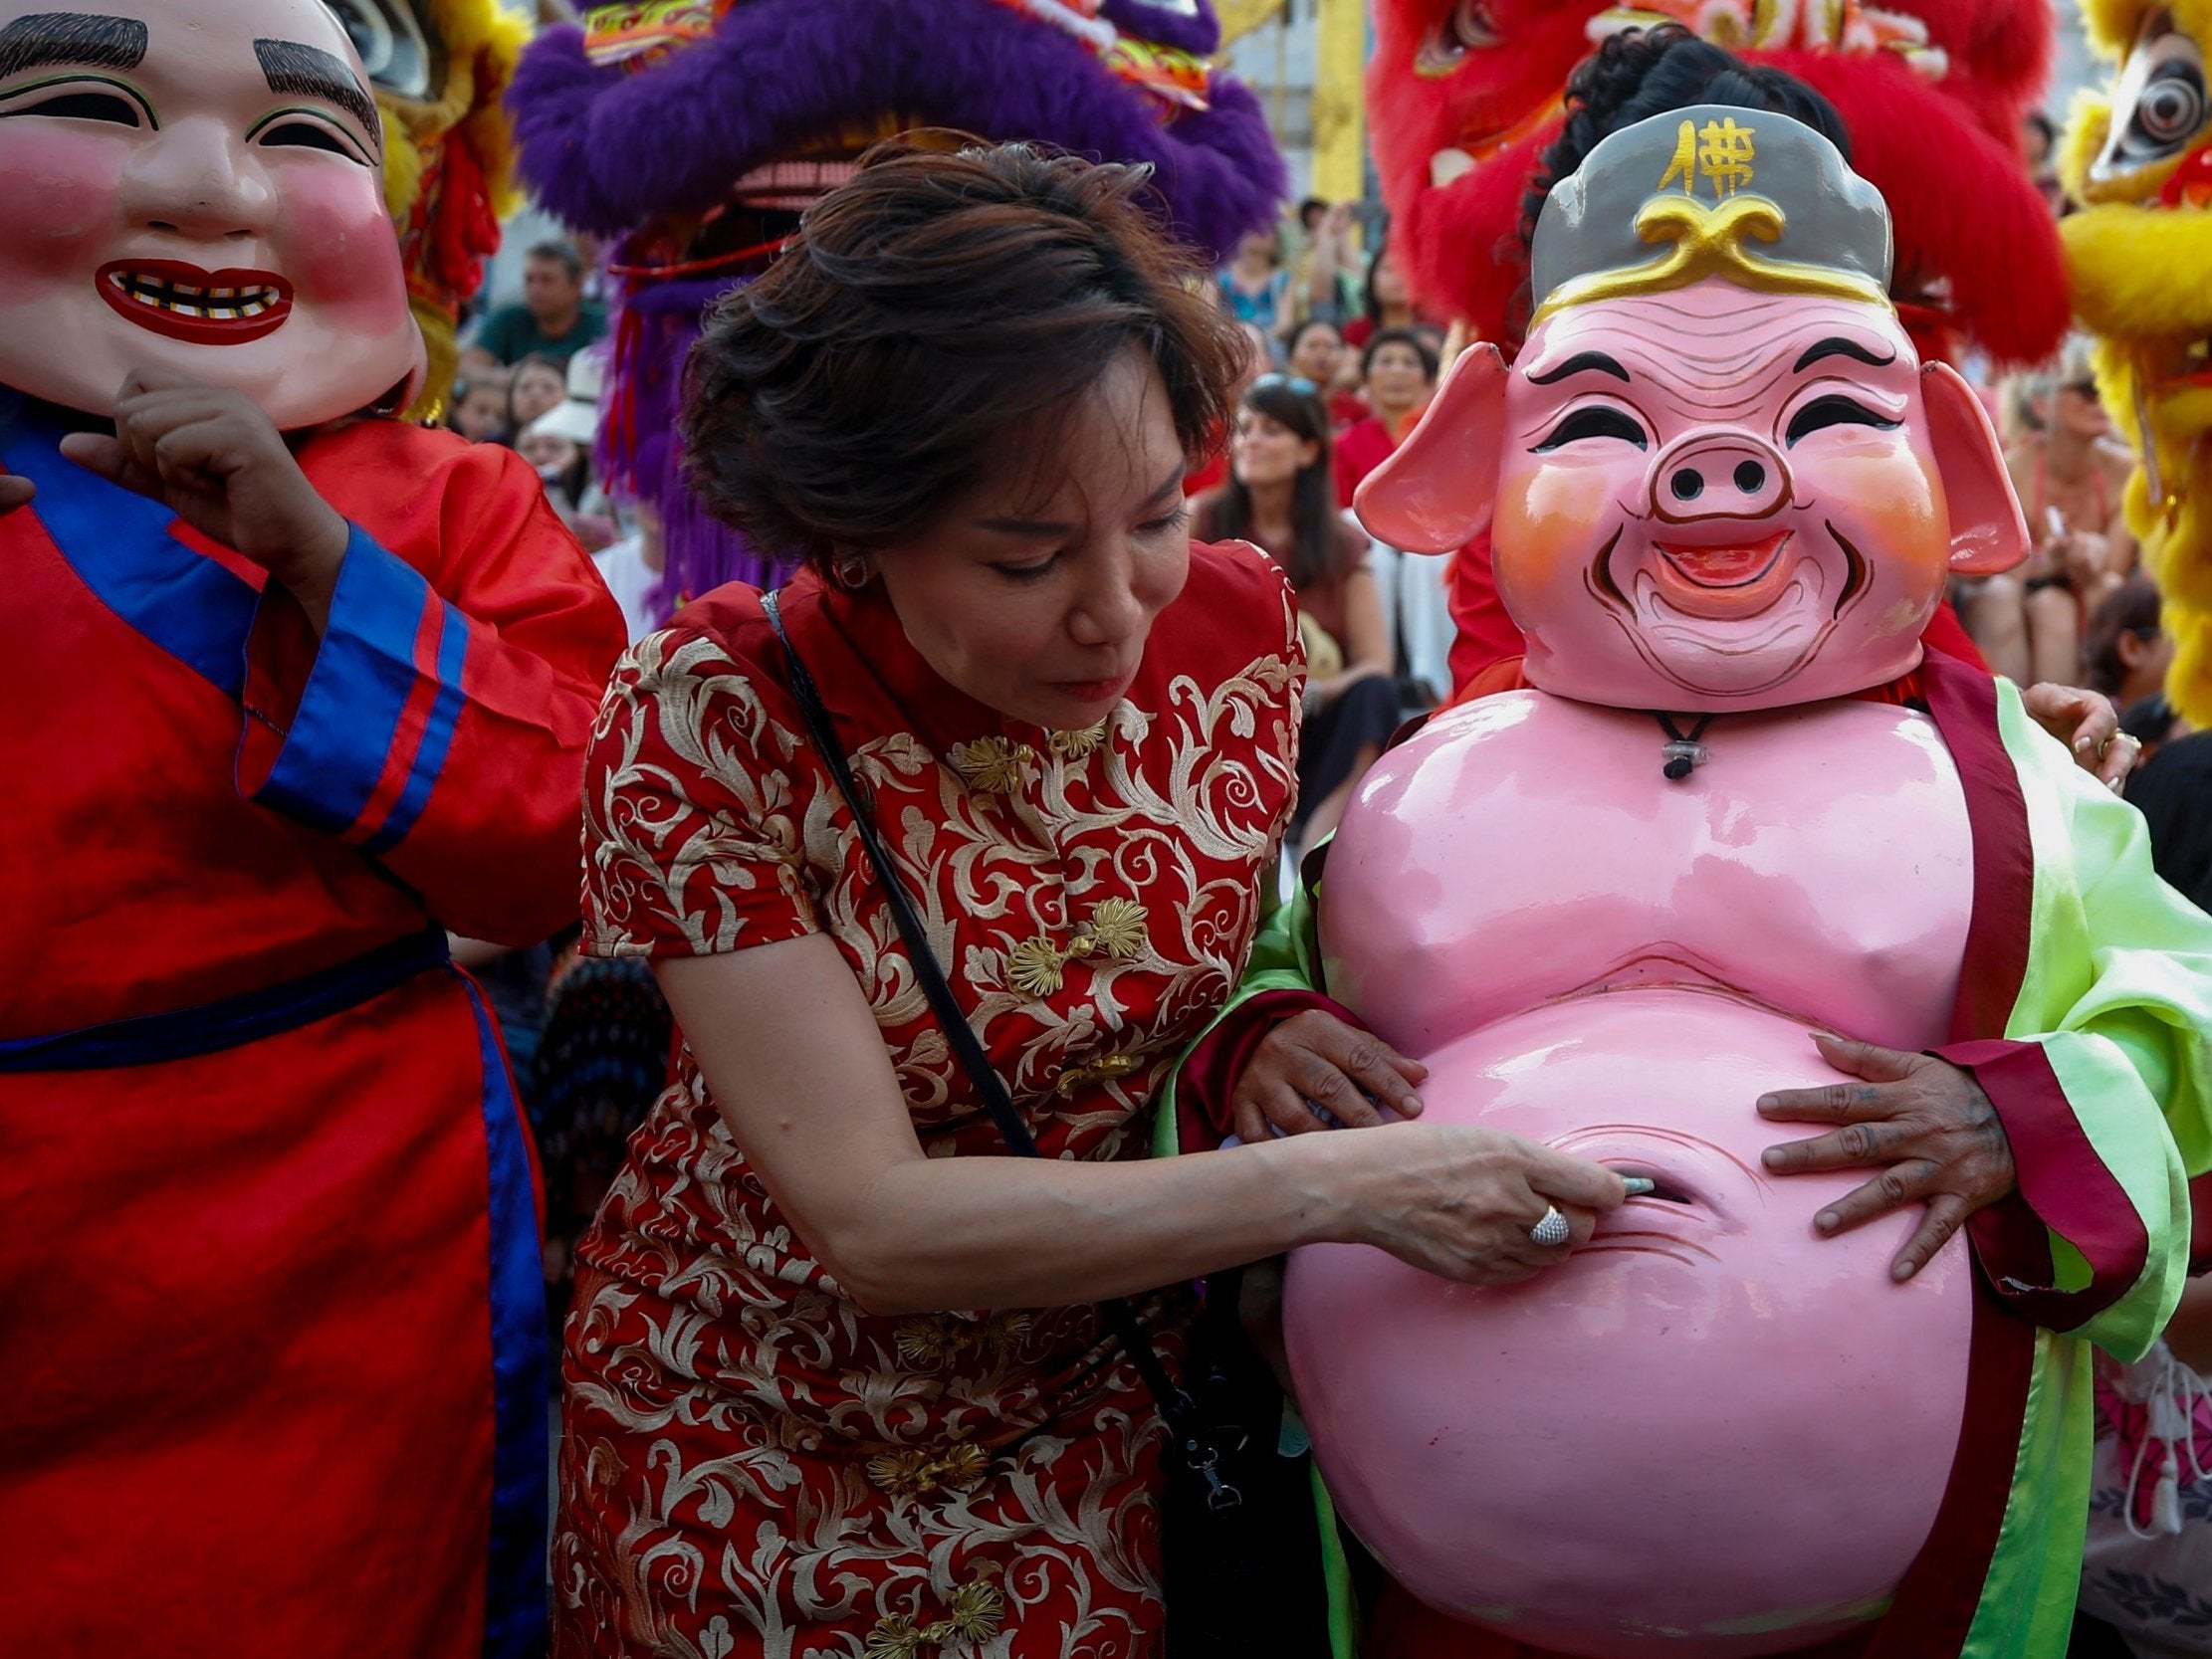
[1358,110,2026,710]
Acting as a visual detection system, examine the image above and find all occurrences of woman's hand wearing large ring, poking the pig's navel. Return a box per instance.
[1343,1124,1628,1285]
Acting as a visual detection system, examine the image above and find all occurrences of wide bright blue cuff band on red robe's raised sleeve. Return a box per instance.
[252,524,442,845]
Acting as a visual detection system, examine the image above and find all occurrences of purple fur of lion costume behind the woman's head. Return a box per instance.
[509,0,1285,599]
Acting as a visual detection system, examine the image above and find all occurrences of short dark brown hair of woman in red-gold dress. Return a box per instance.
[684,143,1243,568]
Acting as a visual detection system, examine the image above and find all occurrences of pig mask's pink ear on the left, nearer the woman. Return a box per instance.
[1352,345,1506,553]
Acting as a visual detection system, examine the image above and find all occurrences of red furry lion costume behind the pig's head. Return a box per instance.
[1367,0,2069,688]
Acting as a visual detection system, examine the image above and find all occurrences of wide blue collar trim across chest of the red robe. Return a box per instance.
[0,427,261,702]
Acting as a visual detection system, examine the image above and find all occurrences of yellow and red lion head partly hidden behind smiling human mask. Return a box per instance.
[328,0,531,416]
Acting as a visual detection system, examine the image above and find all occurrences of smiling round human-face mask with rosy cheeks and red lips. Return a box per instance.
[0,0,422,429]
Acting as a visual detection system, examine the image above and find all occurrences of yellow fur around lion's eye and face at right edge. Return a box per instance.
[2060,0,2212,726]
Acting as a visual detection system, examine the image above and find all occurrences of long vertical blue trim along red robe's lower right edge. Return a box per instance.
[462,977,549,1659]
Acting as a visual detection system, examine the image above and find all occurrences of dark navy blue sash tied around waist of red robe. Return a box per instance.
[0,930,449,1073]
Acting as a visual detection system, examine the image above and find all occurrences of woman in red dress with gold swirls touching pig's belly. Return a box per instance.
[553,148,1622,1659]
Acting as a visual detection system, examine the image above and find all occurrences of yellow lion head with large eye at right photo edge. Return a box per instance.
[2060,0,2212,724]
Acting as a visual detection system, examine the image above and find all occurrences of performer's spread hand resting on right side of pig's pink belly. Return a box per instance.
[1758,1031,2020,1283]
